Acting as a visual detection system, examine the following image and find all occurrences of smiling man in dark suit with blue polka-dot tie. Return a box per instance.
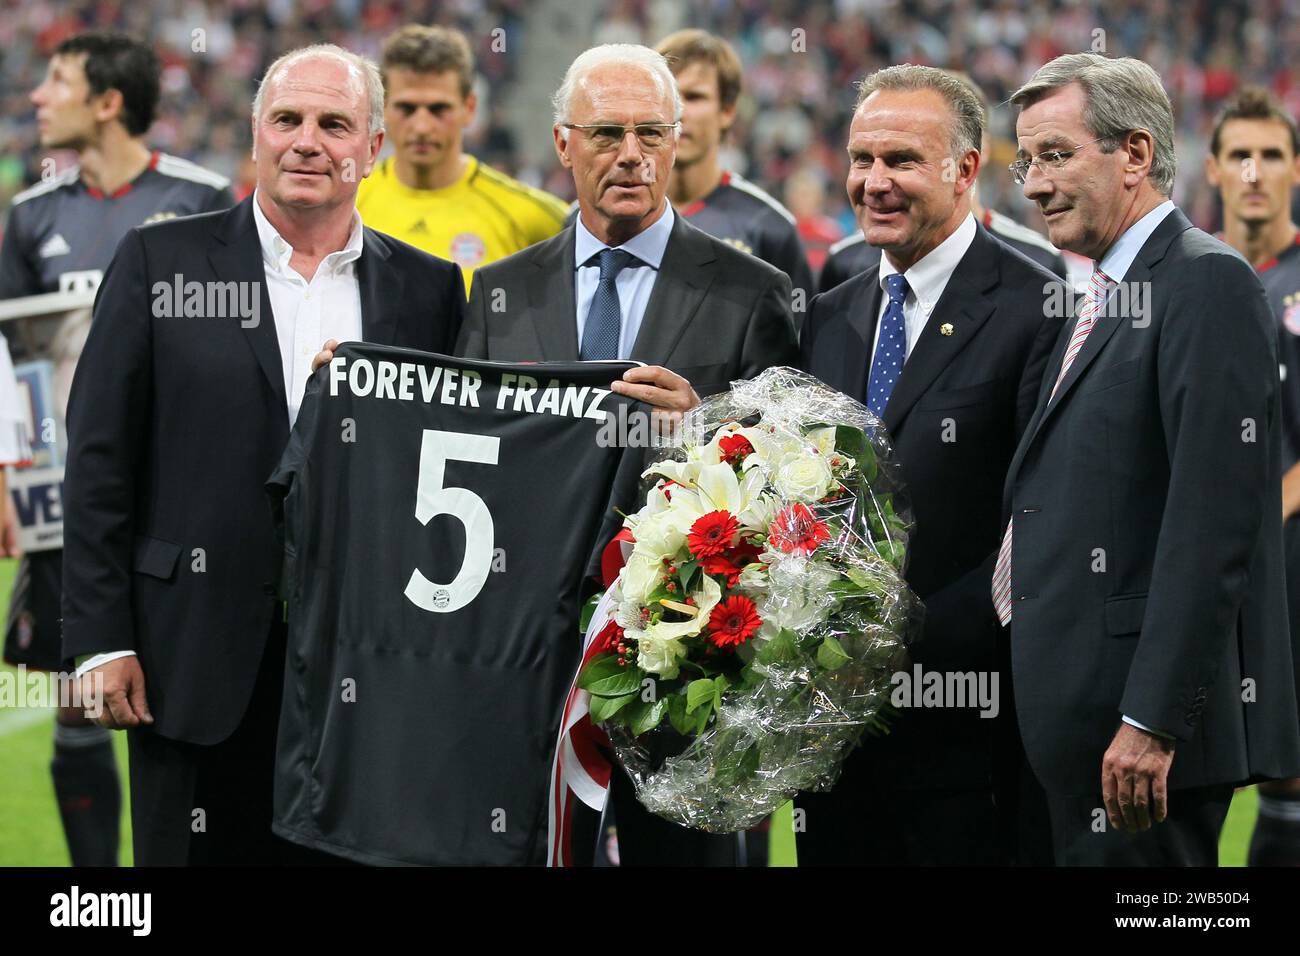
[797,65,1062,865]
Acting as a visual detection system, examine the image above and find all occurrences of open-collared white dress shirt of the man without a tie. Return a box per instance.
[77,191,361,676]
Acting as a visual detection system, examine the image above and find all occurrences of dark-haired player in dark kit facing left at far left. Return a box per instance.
[0,33,234,866]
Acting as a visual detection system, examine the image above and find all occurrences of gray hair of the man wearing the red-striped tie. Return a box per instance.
[1011,53,1178,196]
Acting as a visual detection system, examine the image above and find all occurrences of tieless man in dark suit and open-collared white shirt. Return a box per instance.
[64,47,464,864]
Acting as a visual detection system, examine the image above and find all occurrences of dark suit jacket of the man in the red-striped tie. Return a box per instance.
[1004,209,1300,800]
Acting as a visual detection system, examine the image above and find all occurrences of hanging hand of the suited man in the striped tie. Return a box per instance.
[1101,722,1174,834]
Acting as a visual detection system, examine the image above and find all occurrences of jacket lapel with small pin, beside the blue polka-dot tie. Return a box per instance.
[876,225,1001,434]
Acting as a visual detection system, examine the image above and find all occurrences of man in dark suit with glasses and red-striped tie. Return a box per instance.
[992,53,1300,866]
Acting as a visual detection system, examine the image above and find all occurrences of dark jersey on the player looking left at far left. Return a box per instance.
[0,152,234,299]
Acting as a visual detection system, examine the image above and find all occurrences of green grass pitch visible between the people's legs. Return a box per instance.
[0,561,1256,866]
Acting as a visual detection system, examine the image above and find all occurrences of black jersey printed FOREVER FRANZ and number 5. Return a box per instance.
[268,343,644,865]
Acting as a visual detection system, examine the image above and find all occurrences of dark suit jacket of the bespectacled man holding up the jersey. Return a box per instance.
[456,216,798,395]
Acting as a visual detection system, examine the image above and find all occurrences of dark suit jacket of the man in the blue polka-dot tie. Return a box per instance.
[802,225,1063,797]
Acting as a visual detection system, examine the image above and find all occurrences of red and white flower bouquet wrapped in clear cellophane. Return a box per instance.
[577,368,917,832]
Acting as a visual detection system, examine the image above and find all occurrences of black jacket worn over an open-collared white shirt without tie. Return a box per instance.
[64,198,465,744]
